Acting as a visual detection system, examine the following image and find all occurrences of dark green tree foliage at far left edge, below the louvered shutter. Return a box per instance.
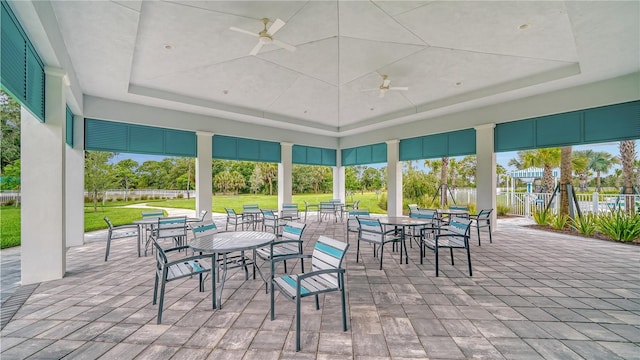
[0,90,21,170]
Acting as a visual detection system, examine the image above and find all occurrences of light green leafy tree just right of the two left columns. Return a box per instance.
[84,151,114,212]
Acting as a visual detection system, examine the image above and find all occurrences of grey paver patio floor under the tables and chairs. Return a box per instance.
[0,218,640,360]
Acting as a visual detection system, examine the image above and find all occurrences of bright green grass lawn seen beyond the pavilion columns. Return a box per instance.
[0,193,386,249]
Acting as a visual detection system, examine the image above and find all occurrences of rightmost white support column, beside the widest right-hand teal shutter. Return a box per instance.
[475,124,497,231]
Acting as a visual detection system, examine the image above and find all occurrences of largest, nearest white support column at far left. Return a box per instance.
[20,68,66,285]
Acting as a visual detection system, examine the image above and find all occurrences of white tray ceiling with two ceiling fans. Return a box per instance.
[35,1,640,137]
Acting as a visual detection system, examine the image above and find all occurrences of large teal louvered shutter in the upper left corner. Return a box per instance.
[0,0,45,122]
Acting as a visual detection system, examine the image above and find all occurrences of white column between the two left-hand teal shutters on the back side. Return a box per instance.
[196,131,213,220]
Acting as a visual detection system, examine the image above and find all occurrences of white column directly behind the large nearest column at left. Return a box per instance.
[63,116,84,247]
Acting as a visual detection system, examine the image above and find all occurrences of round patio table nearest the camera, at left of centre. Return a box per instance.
[189,231,276,309]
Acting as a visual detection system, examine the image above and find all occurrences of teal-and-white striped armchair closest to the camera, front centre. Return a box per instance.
[271,236,349,351]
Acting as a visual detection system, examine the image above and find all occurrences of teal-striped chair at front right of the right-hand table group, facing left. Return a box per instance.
[420,217,473,277]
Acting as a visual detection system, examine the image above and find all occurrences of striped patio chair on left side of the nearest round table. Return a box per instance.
[152,239,211,324]
